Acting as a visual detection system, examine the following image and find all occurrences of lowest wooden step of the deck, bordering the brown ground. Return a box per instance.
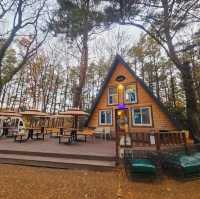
[0,154,115,171]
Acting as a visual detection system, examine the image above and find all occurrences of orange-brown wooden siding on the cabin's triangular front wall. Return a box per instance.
[88,64,176,132]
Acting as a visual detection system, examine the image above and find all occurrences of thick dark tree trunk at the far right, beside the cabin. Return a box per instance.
[179,62,200,142]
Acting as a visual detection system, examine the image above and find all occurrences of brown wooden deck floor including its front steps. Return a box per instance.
[0,137,115,170]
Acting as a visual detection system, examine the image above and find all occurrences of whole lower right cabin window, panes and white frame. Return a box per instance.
[132,107,152,126]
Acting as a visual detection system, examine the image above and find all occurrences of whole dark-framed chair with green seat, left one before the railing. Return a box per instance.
[124,149,161,180]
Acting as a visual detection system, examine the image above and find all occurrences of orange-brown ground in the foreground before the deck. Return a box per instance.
[0,165,200,199]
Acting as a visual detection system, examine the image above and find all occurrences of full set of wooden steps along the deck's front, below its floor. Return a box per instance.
[0,150,115,171]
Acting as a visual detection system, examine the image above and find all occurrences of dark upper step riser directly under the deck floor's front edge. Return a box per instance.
[0,150,116,161]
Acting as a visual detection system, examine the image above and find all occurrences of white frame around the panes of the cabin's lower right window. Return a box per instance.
[131,106,153,127]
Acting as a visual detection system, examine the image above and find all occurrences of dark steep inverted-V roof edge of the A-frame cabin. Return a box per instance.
[86,54,181,129]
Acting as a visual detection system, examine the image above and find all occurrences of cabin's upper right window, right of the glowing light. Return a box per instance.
[125,84,137,103]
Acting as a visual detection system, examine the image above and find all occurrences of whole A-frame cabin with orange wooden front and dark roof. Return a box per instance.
[87,55,179,137]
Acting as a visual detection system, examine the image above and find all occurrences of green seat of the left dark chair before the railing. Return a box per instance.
[131,159,156,174]
